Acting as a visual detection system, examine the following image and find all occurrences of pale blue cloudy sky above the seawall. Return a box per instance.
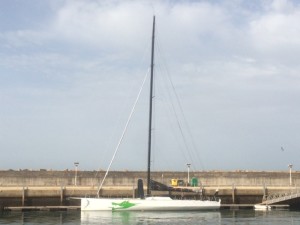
[0,0,300,171]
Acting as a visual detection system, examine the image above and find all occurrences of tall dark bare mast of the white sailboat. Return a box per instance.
[147,16,155,195]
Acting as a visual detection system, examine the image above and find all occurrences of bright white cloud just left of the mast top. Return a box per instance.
[53,1,151,51]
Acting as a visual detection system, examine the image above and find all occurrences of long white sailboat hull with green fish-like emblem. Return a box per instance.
[81,197,221,211]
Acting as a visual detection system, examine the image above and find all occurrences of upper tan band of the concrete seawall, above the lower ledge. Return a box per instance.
[0,170,300,187]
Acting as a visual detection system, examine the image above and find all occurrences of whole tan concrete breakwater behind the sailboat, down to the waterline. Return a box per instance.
[0,170,300,208]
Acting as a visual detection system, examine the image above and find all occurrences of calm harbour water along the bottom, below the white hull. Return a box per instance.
[0,210,300,225]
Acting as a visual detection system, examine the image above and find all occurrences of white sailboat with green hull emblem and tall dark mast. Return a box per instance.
[80,16,221,211]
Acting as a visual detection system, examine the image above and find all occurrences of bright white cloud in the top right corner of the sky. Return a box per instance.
[249,1,300,55]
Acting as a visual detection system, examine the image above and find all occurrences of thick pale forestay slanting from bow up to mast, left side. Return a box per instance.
[97,69,149,198]
